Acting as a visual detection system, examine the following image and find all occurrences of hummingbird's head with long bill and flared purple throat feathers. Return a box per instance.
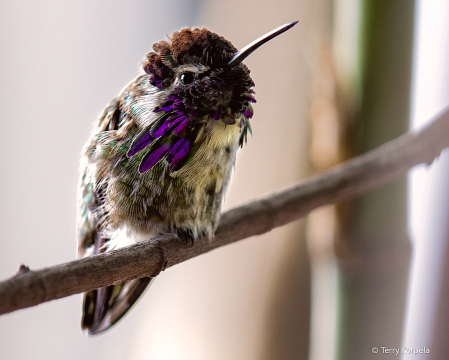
[128,22,297,172]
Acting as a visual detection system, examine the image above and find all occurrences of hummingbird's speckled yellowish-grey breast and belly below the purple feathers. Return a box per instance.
[108,119,238,237]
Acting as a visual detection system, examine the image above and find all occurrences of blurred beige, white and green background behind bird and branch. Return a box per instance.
[0,0,449,360]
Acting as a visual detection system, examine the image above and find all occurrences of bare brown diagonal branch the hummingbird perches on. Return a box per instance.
[0,110,449,314]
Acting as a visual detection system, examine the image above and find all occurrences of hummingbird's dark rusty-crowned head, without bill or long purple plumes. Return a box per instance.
[144,28,255,125]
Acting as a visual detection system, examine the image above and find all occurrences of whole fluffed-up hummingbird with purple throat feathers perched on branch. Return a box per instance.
[77,21,297,335]
